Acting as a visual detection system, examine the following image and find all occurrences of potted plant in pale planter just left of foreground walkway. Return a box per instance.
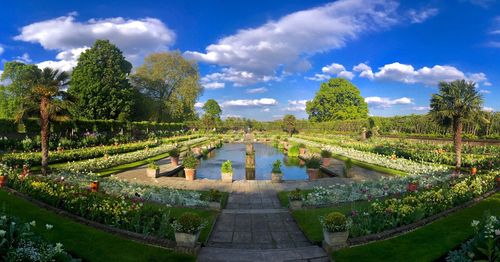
[172,212,205,247]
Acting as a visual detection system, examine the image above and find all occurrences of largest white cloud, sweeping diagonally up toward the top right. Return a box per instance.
[185,0,398,85]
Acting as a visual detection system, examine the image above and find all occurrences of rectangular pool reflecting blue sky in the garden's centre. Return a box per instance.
[189,143,325,180]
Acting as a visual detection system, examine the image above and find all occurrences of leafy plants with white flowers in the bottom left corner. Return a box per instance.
[0,212,74,262]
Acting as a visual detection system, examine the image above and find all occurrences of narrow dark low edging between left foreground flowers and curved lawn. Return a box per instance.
[0,187,203,255]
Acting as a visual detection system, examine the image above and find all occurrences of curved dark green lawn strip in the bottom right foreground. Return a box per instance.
[332,193,500,261]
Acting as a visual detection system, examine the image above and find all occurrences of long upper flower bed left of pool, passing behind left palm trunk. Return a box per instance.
[0,135,200,166]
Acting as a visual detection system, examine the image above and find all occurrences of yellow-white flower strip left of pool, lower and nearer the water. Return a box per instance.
[58,137,207,172]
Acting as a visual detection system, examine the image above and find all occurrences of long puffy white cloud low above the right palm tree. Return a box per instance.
[355,62,488,86]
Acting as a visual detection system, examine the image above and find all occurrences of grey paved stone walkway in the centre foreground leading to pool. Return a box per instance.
[198,188,329,262]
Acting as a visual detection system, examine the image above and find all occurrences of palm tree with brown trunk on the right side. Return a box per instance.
[430,80,483,169]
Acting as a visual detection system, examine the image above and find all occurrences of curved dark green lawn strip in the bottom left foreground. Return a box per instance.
[0,190,196,262]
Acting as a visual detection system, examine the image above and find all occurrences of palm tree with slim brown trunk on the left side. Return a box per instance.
[16,68,71,175]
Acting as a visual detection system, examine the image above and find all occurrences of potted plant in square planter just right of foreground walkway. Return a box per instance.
[320,212,349,249]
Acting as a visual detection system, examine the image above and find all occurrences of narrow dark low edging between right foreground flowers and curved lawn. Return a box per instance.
[348,189,500,247]
